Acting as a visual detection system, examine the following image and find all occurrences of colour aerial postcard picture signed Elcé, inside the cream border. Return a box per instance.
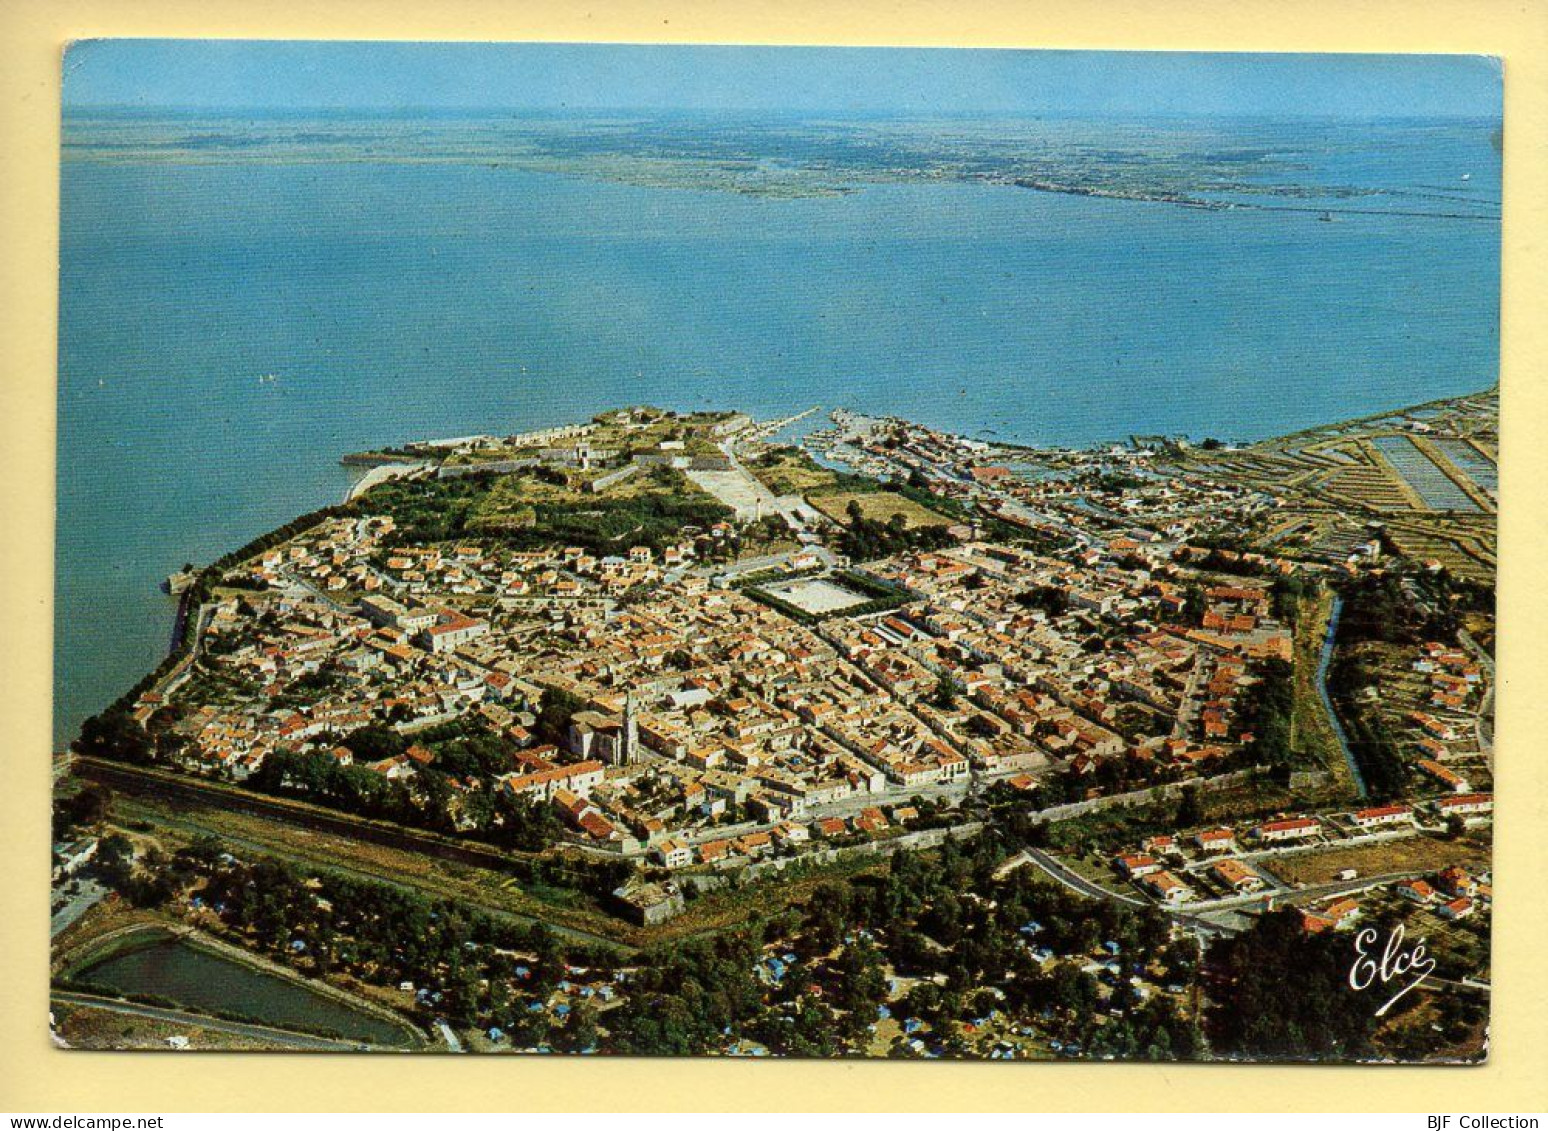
[51,39,1503,1074]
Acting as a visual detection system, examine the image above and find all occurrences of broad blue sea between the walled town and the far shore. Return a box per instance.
[54,119,1498,741]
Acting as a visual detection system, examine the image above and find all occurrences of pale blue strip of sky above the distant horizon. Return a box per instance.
[63,39,1502,118]
